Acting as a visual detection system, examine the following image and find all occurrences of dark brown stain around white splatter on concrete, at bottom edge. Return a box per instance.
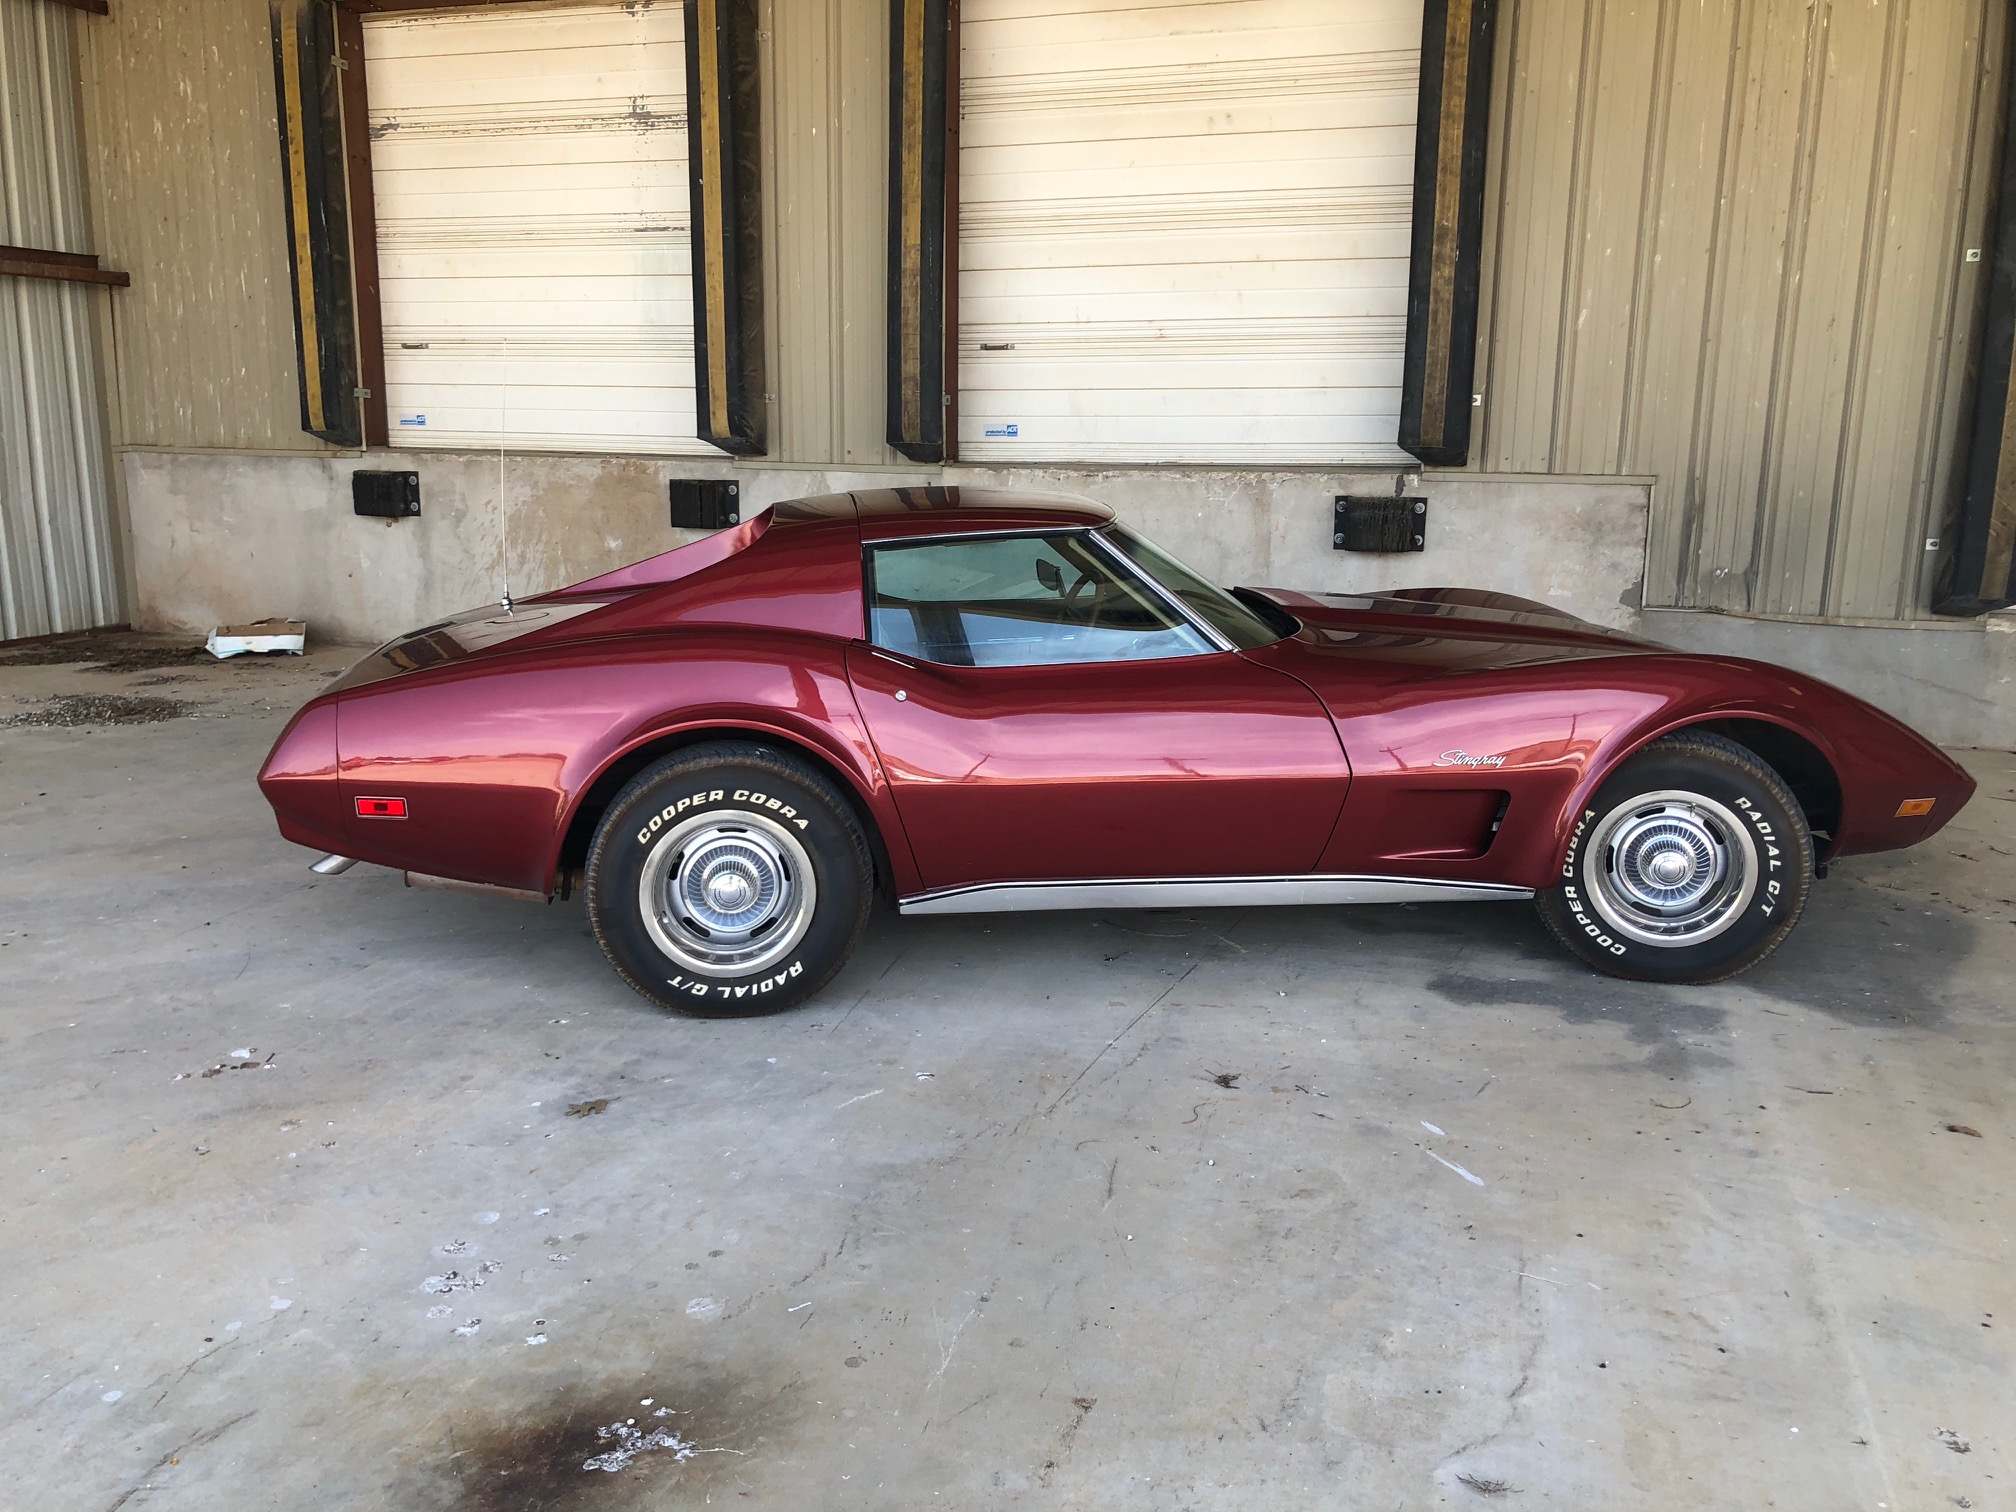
[433,1371,812,1512]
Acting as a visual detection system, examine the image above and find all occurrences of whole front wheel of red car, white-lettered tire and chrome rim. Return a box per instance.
[1534,734,1812,982]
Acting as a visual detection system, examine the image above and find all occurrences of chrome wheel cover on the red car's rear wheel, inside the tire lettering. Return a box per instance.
[637,810,818,976]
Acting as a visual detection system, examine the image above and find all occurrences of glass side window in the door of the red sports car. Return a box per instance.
[869,534,1218,667]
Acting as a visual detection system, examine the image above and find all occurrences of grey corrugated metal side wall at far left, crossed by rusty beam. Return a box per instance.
[0,0,119,641]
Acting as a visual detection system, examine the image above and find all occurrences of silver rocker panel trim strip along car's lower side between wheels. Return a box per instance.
[897,875,1532,913]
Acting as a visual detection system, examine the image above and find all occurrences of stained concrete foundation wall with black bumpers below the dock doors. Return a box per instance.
[123,452,1647,641]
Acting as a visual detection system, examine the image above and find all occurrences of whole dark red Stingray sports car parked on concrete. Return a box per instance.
[260,488,1974,1016]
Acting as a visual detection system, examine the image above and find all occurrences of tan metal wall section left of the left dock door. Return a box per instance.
[81,0,329,452]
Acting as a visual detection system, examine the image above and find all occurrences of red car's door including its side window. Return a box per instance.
[847,530,1349,889]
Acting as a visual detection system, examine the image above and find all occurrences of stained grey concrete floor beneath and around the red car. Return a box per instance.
[0,651,2016,1512]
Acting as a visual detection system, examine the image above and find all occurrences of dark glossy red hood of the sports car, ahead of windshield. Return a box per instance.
[1240,589,1671,675]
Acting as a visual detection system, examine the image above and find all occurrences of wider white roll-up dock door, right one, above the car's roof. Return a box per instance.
[960,0,1421,466]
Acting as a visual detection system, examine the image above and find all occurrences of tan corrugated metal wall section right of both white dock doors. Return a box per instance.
[1476,0,2006,619]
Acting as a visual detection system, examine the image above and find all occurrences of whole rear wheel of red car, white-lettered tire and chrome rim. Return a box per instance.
[587,740,875,1018]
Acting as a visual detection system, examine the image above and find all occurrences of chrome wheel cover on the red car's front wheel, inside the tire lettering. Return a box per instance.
[1585,792,1758,948]
